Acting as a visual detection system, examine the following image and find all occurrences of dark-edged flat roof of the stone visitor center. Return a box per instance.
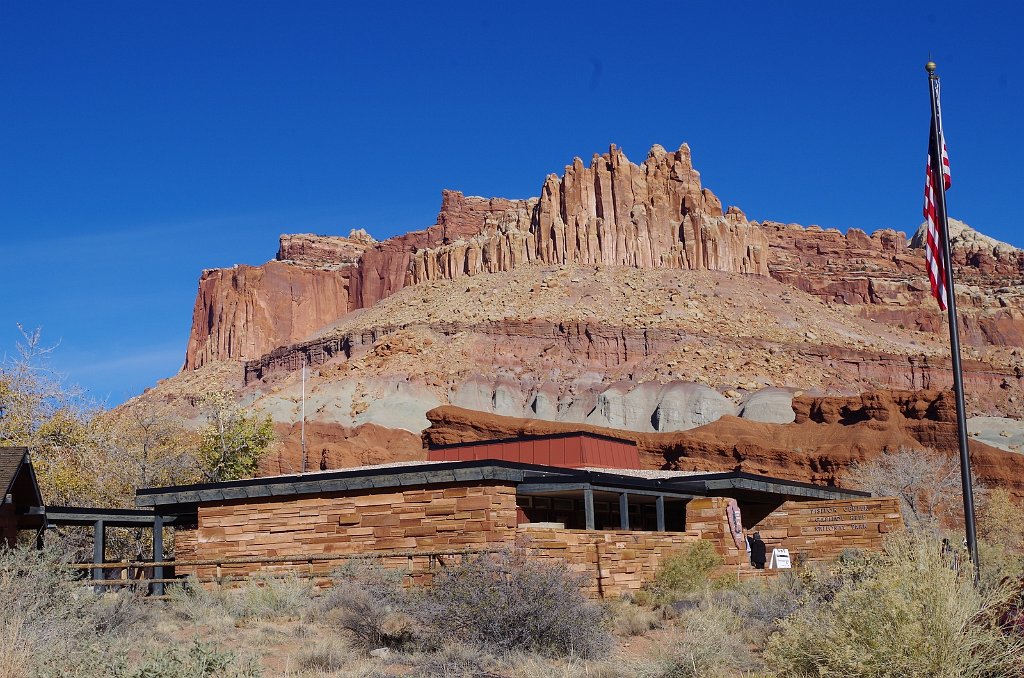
[135,460,870,510]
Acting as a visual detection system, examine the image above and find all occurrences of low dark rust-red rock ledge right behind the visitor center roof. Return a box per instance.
[423,391,1024,498]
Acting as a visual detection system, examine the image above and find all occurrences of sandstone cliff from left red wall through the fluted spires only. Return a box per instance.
[184,144,768,370]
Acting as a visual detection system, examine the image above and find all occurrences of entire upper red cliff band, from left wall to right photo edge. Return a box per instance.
[184,144,1024,369]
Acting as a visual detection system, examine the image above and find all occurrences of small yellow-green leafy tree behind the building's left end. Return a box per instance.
[199,391,274,482]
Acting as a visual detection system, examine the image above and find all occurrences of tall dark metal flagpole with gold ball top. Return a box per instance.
[925,61,980,582]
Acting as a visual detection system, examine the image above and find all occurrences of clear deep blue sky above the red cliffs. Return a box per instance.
[0,0,1024,405]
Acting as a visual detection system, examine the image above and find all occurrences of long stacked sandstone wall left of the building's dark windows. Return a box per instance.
[174,483,516,577]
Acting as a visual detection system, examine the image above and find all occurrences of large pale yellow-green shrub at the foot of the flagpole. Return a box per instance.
[765,535,1024,676]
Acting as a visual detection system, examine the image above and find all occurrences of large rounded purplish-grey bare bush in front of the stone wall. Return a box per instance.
[420,548,610,658]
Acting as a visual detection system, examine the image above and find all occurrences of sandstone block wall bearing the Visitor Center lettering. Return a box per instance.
[748,497,903,564]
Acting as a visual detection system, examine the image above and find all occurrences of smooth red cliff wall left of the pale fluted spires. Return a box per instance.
[183,190,526,370]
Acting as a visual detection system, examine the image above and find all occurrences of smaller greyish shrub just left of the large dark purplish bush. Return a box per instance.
[315,560,418,649]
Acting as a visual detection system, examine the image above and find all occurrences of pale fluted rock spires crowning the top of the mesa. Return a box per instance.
[412,144,768,283]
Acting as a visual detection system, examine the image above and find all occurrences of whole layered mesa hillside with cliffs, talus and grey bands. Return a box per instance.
[128,144,1024,483]
